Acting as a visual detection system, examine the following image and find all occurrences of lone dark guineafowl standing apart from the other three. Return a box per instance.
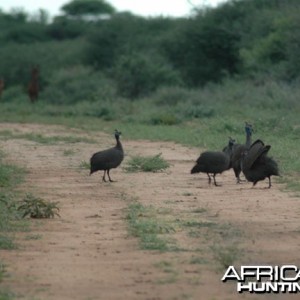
[90,130,124,182]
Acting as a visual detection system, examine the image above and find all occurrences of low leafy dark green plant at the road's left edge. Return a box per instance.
[18,194,59,219]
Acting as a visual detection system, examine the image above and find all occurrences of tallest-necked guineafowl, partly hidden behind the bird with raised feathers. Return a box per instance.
[231,122,253,183]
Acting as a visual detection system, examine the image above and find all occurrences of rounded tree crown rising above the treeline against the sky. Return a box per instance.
[61,0,116,18]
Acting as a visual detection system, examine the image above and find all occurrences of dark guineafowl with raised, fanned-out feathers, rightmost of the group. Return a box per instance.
[241,140,279,188]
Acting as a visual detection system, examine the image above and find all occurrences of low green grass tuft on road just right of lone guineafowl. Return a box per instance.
[125,153,170,172]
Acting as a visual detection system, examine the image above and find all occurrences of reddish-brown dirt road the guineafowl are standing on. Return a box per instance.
[0,123,300,300]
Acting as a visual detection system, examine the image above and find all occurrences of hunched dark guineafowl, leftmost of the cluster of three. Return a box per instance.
[191,139,234,186]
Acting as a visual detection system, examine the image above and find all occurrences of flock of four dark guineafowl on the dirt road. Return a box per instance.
[90,122,279,188]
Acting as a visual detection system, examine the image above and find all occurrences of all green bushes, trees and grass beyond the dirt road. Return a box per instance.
[0,0,300,188]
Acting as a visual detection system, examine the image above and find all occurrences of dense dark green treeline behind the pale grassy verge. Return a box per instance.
[0,0,300,104]
